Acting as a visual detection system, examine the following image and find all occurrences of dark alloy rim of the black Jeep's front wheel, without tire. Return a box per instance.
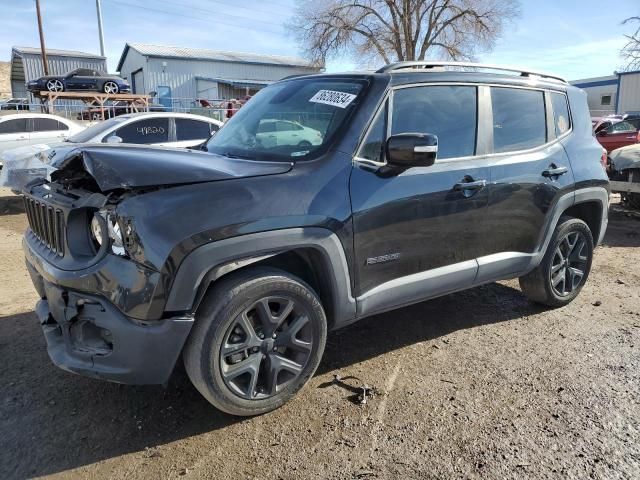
[220,296,313,400]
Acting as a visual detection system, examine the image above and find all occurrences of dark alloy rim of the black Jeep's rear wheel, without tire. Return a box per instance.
[550,232,589,297]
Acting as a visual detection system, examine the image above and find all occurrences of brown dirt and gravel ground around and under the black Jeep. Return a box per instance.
[0,188,640,479]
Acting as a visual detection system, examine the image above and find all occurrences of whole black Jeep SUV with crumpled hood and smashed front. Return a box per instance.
[23,62,609,415]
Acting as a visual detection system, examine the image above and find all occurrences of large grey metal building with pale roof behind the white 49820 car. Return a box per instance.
[117,43,320,108]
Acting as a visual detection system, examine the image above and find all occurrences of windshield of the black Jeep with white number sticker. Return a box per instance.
[206,78,365,161]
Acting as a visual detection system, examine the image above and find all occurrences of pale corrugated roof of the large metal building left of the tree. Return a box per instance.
[118,43,313,71]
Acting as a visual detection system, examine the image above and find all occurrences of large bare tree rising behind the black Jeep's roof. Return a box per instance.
[290,0,520,63]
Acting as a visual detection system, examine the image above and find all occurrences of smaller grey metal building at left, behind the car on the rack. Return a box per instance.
[11,47,107,101]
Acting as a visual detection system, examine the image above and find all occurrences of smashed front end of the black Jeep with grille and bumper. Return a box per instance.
[21,144,198,384]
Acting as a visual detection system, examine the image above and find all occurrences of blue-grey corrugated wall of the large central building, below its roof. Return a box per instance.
[120,52,317,108]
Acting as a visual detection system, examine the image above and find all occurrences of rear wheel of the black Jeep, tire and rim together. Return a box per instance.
[520,216,594,307]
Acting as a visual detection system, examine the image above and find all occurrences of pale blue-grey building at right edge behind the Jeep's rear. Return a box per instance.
[571,70,640,117]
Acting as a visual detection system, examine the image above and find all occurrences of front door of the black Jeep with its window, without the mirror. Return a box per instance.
[350,85,490,315]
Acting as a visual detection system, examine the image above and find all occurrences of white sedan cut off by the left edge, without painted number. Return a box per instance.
[0,113,84,152]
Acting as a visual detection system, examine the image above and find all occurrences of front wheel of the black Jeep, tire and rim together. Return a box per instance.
[183,267,327,416]
